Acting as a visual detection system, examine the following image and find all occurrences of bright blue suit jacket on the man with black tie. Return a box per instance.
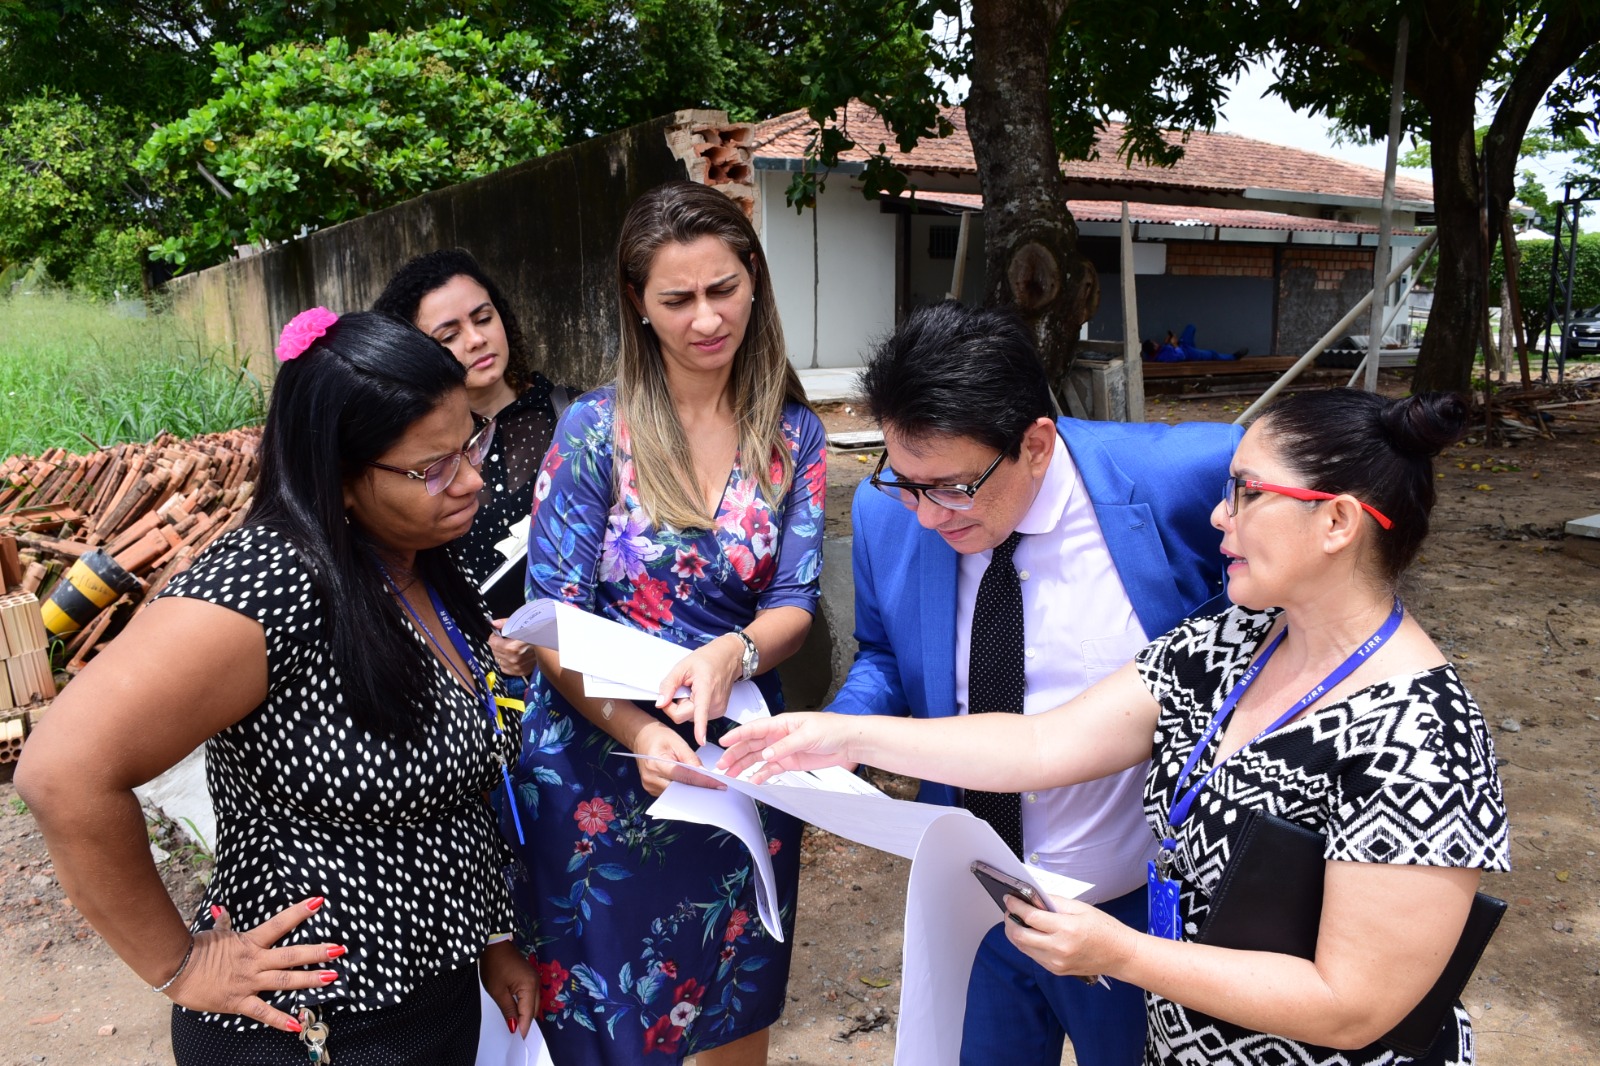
[827,418,1243,804]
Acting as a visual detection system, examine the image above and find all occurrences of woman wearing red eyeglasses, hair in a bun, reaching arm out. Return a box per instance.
[722,389,1509,1066]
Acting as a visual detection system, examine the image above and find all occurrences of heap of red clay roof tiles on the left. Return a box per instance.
[0,429,261,694]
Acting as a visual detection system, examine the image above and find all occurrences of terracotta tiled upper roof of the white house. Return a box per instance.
[754,101,1434,203]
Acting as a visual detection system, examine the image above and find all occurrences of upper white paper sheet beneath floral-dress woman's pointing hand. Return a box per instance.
[501,600,768,723]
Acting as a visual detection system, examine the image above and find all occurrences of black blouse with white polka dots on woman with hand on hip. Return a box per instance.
[162,527,520,1028]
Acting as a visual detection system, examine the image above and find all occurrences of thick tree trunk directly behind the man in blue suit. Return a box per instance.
[966,0,1099,406]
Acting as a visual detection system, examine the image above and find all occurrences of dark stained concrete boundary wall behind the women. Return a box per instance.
[166,118,707,387]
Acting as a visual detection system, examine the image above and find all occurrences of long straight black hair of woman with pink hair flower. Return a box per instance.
[245,312,490,738]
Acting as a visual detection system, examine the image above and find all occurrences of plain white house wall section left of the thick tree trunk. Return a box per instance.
[757,170,896,368]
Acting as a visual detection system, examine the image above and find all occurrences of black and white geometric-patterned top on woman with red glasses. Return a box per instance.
[1136,607,1510,1066]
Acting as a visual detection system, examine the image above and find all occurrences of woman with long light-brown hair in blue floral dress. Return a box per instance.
[514,182,826,1066]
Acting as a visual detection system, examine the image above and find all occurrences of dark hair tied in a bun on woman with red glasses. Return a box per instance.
[1259,389,1467,584]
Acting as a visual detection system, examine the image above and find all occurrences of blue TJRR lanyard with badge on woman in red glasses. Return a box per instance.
[1147,599,1405,940]
